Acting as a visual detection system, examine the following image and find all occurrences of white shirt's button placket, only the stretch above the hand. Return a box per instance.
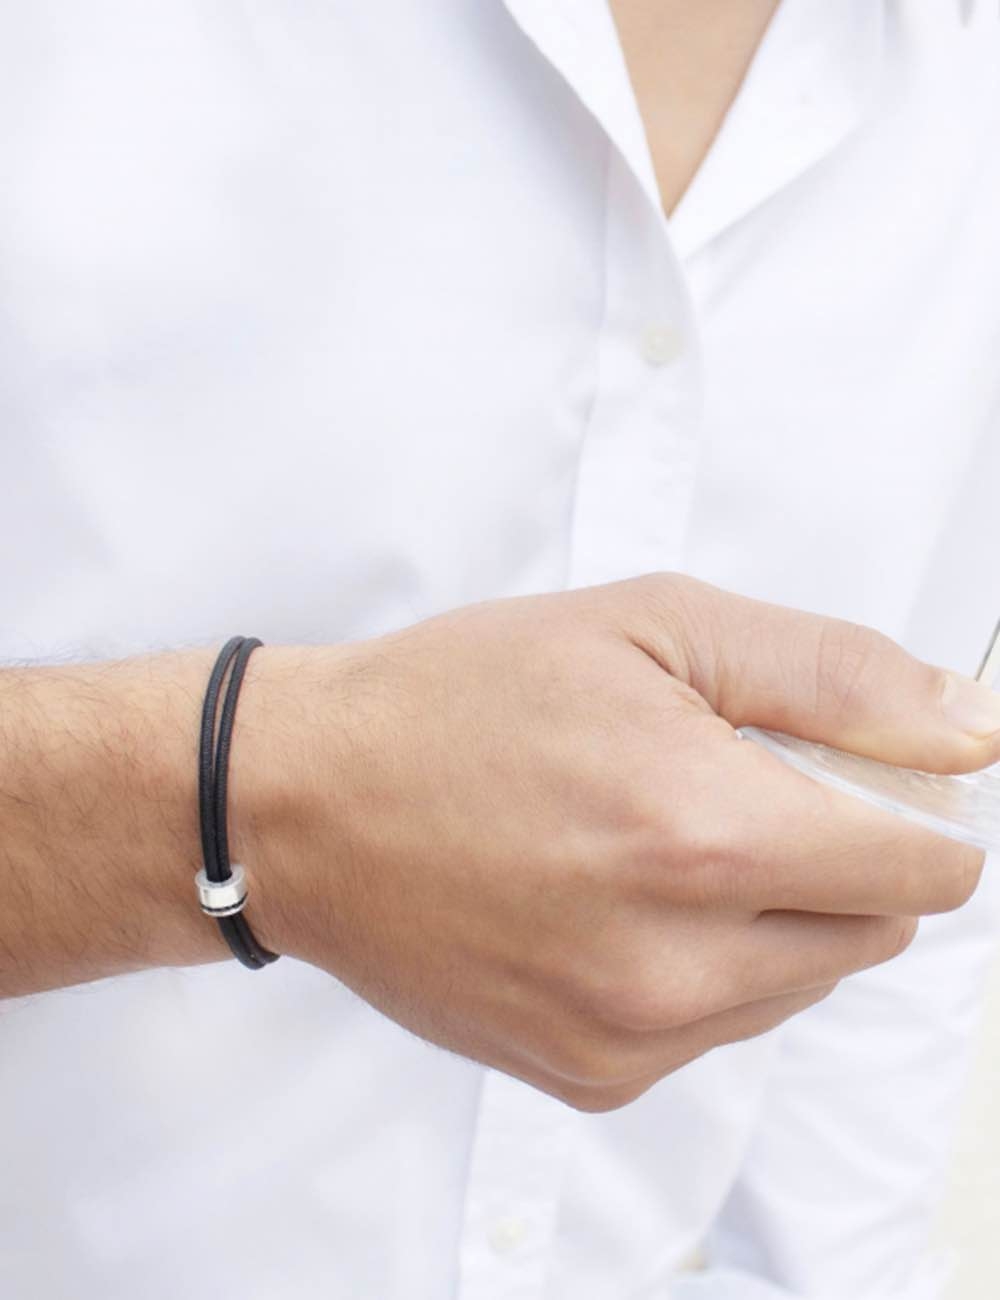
[507,0,702,586]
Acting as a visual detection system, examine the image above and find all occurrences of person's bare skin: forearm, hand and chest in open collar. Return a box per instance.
[0,0,1000,1110]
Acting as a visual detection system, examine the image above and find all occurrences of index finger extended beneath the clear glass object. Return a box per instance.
[650,720,984,917]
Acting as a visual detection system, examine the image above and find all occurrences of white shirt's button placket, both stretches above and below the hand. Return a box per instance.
[456,0,701,1300]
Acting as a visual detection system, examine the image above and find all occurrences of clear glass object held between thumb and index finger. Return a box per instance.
[740,623,1000,852]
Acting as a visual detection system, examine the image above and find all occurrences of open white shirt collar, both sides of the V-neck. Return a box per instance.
[505,0,884,256]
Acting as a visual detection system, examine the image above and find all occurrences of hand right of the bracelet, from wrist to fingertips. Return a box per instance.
[231,575,1000,1110]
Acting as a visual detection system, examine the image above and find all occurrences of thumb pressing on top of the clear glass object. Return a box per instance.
[632,573,1000,772]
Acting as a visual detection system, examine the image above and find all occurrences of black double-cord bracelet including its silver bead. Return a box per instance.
[195,637,278,971]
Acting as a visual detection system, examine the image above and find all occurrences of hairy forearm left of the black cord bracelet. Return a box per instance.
[0,649,288,997]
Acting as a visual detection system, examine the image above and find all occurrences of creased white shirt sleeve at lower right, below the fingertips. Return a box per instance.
[671,855,1000,1300]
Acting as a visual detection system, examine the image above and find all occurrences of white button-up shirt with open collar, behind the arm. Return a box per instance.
[0,0,1000,1300]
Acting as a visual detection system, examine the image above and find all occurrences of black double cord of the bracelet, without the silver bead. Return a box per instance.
[198,637,278,970]
